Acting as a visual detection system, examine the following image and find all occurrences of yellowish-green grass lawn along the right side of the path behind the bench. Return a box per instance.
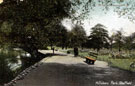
[61,50,135,72]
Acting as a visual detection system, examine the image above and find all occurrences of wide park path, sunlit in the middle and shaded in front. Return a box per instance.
[15,51,135,86]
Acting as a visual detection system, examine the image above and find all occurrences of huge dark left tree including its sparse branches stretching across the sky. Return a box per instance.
[0,0,134,57]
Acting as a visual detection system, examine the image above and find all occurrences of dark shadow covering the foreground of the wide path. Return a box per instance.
[15,63,135,86]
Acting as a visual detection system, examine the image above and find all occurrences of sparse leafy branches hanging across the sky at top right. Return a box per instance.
[70,0,135,21]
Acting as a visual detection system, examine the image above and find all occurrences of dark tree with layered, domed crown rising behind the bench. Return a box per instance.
[89,24,109,51]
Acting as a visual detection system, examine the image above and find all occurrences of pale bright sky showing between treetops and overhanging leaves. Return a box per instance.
[62,0,135,35]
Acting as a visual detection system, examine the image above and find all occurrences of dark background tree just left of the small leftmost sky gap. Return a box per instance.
[47,24,68,49]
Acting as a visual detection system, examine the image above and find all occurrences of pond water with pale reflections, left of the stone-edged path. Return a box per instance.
[0,49,34,85]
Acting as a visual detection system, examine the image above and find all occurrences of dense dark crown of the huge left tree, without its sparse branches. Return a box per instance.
[0,0,71,58]
